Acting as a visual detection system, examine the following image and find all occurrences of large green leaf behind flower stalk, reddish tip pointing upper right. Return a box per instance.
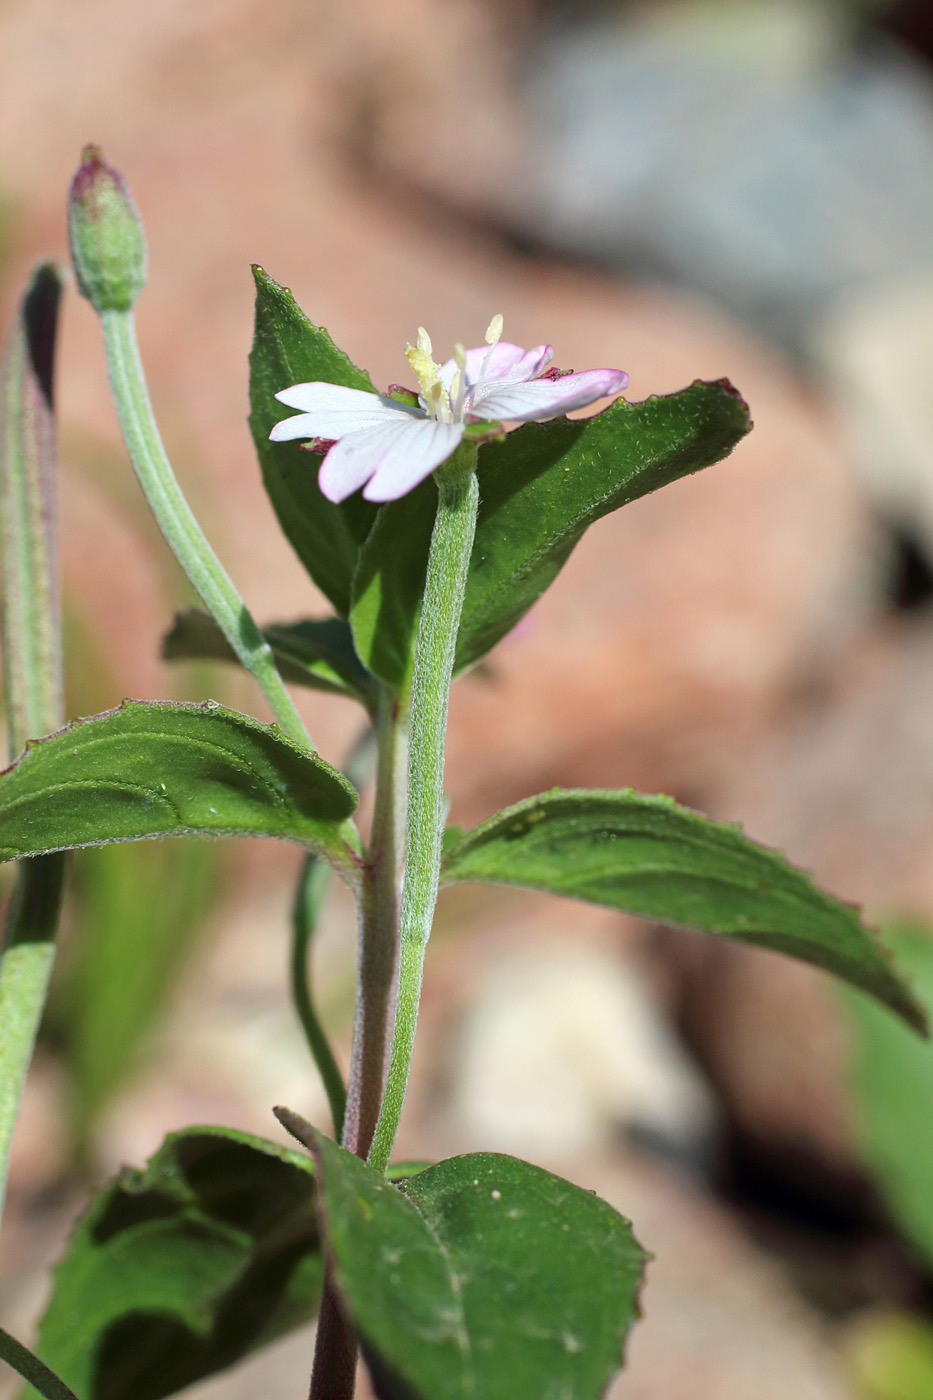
[352,379,751,689]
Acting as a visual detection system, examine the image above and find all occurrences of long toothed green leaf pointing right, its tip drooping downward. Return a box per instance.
[441,788,926,1029]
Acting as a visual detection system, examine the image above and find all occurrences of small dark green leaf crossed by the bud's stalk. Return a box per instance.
[163,608,375,706]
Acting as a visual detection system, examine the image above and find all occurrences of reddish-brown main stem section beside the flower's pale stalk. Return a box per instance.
[342,687,406,1156]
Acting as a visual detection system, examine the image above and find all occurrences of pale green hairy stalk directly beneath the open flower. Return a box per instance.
[370,447,479,1172]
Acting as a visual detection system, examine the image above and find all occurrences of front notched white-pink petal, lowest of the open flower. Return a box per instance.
[318,417,464,501]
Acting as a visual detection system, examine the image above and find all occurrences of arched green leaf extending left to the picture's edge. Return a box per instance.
[0,700,356,860]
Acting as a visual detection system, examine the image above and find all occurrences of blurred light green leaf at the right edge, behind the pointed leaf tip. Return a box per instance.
[845,924,933,1266]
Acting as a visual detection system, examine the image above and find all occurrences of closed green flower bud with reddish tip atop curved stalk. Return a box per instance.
[69,146,146,311]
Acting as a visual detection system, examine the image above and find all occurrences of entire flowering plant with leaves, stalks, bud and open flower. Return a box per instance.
[0,148,922,1400]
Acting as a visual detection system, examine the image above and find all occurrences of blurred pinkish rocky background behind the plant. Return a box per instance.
[0,0,933,1400]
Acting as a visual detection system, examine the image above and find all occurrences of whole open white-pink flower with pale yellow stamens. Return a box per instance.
[269,316,629,501]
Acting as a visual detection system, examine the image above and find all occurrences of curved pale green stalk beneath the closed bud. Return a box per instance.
[101,311,308,753]
